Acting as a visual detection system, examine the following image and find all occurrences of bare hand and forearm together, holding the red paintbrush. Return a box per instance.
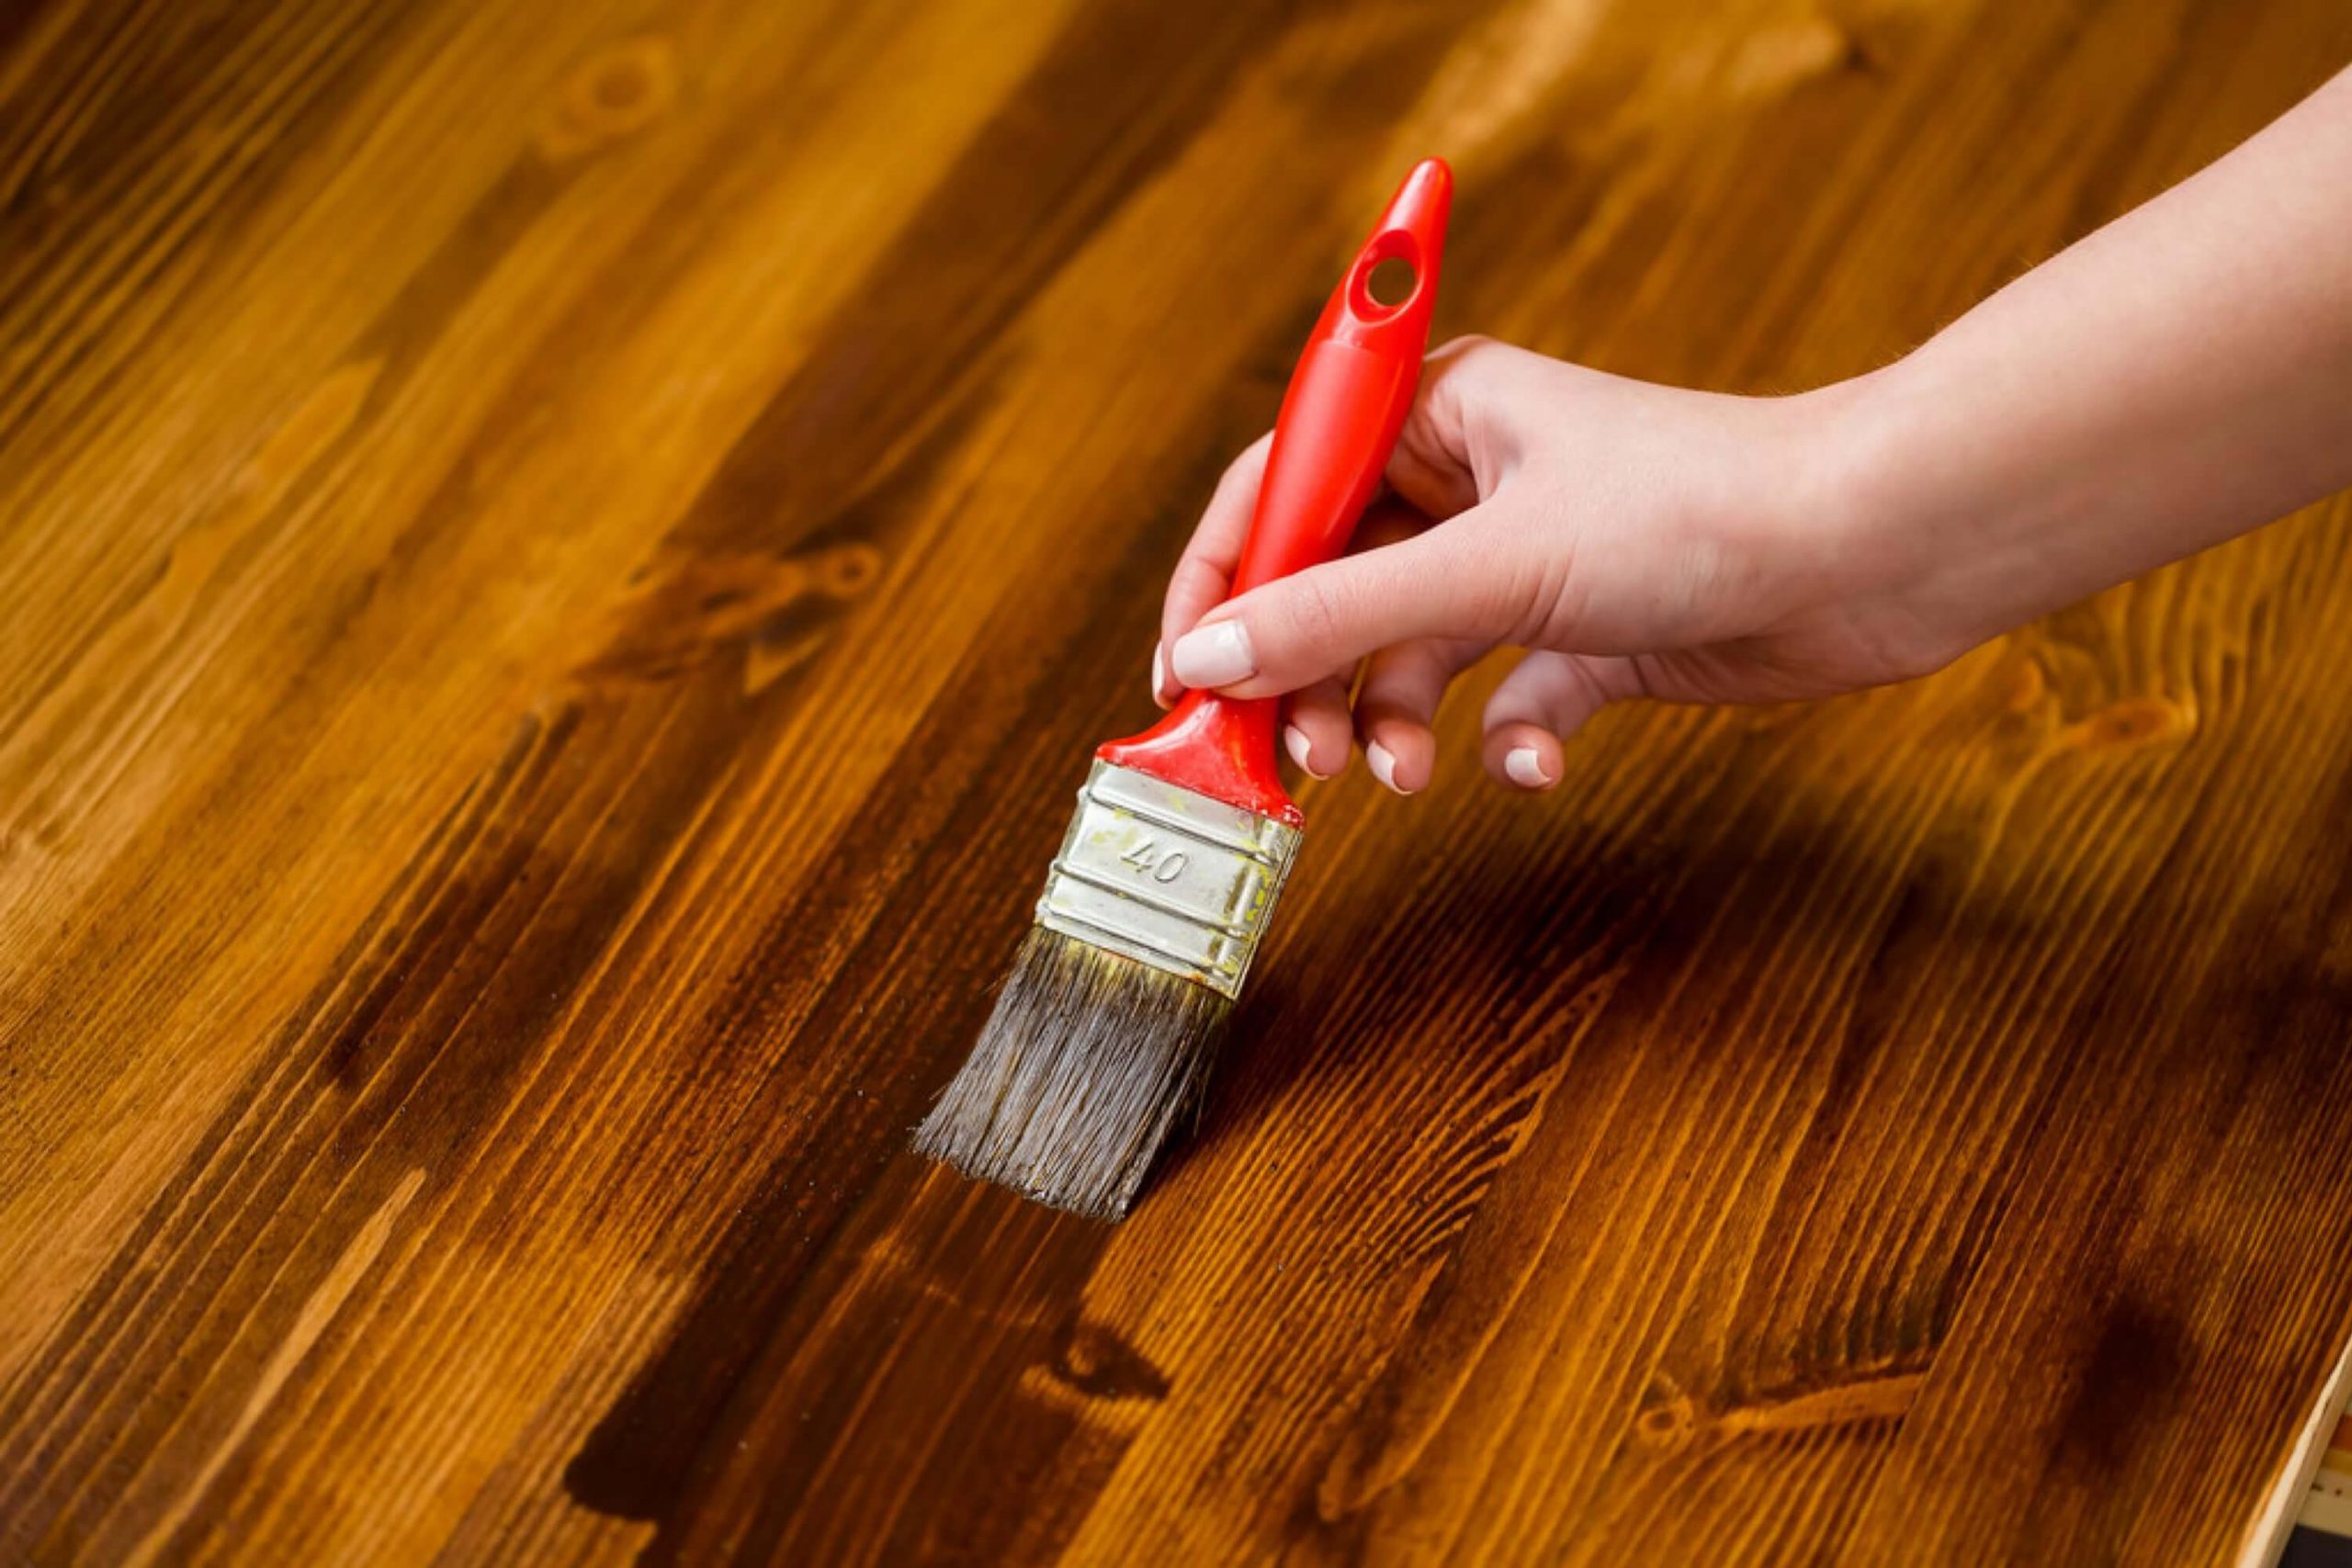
[1152,71,2352,795]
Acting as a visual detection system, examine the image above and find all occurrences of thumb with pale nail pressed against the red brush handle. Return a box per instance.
[1169,505,1541,696]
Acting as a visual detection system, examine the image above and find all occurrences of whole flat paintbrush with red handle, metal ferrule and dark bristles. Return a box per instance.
[915,157,1453,1220]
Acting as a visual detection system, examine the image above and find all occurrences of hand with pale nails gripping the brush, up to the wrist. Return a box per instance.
[1152,339,1938,795]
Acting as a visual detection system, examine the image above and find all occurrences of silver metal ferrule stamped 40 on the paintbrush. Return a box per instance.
[1037,760,1298,997]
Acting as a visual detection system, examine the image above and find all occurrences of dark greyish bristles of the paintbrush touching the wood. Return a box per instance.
[915,926,1232,1220]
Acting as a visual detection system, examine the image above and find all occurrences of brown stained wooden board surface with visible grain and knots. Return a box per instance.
[0,0,2352,1563]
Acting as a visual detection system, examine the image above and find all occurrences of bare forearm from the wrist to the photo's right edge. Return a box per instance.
[1841,73,2352,639]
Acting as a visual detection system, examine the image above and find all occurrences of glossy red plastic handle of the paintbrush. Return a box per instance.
[1096,157,1453,825]
